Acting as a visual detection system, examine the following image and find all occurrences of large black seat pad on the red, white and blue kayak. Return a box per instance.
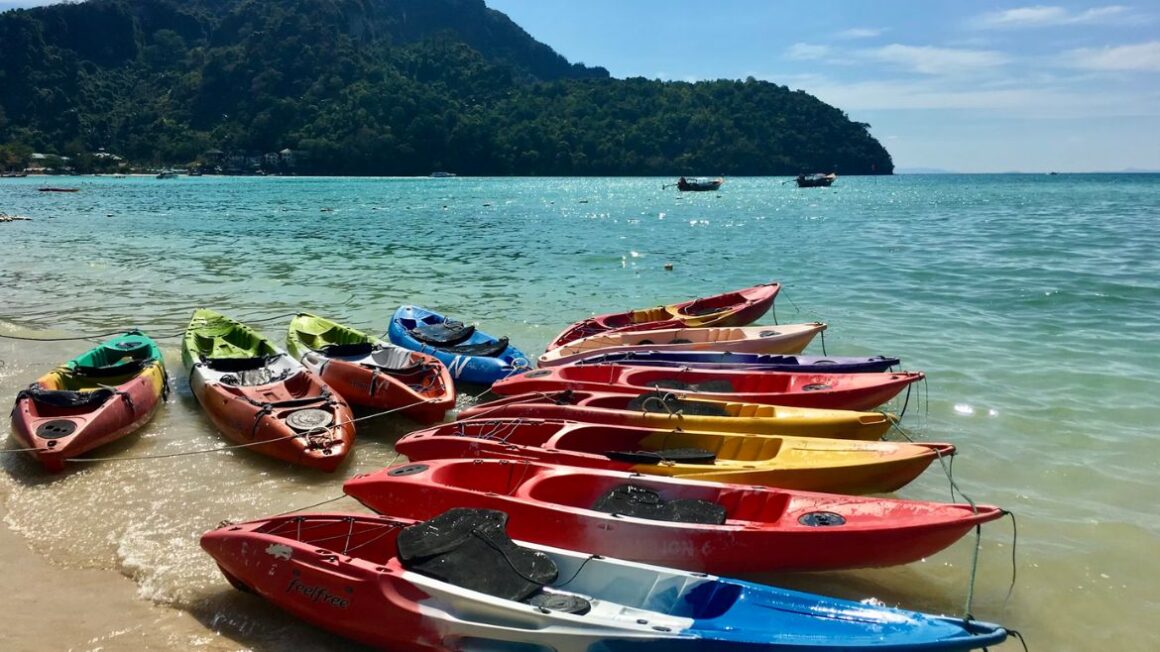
[396,507,559,601]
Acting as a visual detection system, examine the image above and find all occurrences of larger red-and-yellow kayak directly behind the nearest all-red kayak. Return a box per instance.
[394,419,955,493]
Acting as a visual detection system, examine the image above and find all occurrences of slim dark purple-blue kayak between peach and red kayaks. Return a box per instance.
[572,350,901,374]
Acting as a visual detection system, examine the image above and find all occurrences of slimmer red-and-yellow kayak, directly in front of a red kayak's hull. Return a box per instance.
[459,390,898,441]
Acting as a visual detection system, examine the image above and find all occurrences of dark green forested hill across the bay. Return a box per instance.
[0,0,893,175]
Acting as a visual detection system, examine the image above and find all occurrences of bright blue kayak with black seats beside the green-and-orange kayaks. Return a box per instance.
[386,305,531,385]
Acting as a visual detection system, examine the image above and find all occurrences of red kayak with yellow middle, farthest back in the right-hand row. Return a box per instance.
[548,283,782,350]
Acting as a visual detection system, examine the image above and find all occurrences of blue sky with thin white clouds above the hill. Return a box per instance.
[0,0,1160,172]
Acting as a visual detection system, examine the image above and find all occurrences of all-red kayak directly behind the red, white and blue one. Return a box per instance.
[342,459,1003,574]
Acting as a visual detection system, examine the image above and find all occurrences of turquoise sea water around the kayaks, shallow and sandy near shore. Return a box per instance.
[0,175,1160,650]
